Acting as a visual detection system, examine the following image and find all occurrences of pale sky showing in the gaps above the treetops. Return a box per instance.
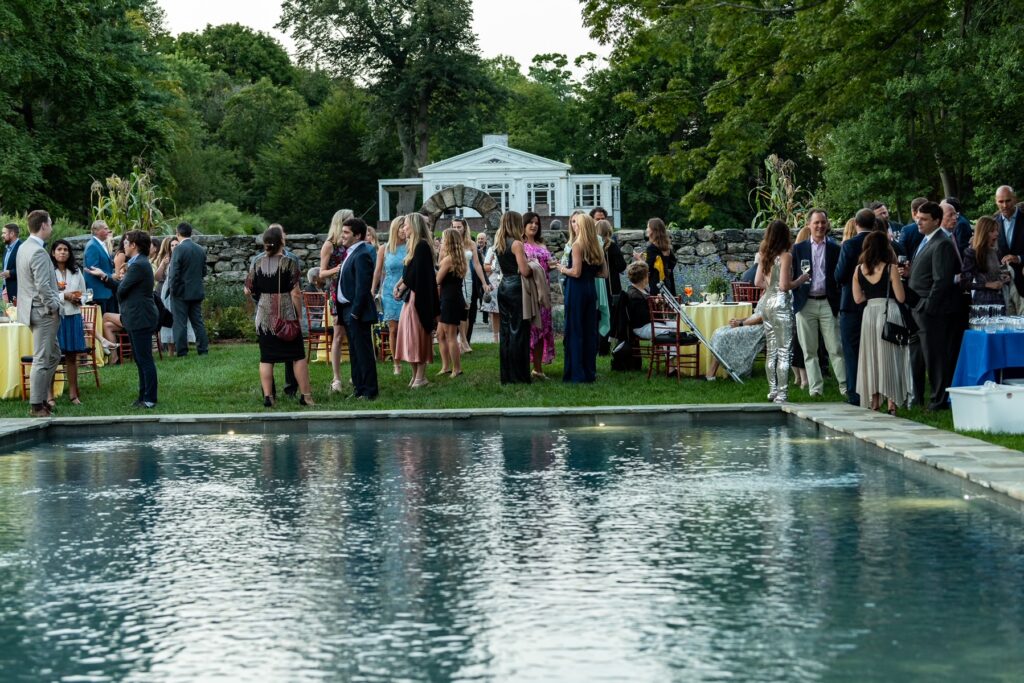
[159,0,608,73]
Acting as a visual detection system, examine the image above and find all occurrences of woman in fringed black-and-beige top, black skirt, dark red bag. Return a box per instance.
[246,226,313,408]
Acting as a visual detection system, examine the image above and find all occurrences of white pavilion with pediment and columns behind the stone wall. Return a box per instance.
[377,135,622,228]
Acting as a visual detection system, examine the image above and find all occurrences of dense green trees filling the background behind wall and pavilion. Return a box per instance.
[0,0,1024,232]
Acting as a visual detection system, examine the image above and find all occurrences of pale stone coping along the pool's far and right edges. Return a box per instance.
[0,403,1024,512]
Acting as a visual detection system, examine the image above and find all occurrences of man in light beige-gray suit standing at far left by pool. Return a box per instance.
[17,211,60,418]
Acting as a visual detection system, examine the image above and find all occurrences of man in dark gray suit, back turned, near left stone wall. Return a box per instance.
[167,223,210,357]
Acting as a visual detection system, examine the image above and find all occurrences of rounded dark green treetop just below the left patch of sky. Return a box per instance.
[176,24,294,85]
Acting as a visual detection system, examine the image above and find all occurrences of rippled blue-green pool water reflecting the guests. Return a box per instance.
[0,424,1024,682]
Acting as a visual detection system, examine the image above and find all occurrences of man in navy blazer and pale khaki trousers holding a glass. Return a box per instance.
[793,209,846,396]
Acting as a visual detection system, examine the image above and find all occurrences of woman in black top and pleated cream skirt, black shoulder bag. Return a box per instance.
[853,231,909,415]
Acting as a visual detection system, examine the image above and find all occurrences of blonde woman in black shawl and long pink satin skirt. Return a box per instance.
[391,213,438,389]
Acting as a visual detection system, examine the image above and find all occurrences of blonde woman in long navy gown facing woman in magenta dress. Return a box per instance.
[559,214,604,383]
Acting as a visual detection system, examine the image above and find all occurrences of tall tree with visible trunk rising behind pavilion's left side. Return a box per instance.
[281,0,484,212]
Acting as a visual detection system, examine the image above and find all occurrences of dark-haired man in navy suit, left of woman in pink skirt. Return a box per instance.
[338,218,378,400]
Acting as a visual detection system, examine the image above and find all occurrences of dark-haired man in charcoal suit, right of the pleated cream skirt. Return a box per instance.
[900,202,962,411]
